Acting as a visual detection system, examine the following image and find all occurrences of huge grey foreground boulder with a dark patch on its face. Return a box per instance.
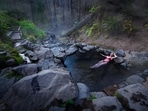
[4,69,78,111]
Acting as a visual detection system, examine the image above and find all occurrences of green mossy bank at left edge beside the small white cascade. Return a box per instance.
[0,43,23,68]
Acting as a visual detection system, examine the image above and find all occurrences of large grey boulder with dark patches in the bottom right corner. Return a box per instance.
[117,83,148,111]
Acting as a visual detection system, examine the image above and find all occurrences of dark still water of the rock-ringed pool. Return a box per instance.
[65,52,145,91]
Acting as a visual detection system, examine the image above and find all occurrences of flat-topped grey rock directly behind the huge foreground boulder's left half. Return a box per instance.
[12,64,38,76]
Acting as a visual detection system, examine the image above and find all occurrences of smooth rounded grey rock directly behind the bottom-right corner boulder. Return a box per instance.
[126,75,144,84]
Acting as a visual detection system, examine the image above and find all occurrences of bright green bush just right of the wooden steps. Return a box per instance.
[19,20,45,41]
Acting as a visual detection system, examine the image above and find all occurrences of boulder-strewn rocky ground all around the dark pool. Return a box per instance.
[0,35,148,111]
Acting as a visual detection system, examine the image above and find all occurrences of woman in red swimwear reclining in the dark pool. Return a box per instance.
[90,52,117,69]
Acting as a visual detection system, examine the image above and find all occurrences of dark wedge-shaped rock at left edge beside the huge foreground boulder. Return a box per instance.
[0,76,15,99]
